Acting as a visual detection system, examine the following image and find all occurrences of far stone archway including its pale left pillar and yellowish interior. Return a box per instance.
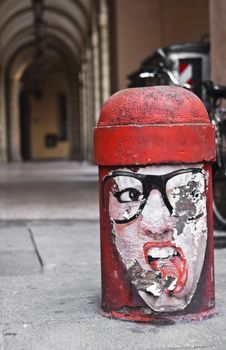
[6,47,81,161]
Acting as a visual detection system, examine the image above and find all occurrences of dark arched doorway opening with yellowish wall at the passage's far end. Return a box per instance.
[19,57,70,161]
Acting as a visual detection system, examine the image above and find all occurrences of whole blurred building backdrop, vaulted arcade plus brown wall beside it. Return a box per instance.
[0,0,222,163]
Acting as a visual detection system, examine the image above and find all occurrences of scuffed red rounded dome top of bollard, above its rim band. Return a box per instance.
[98,86,209,126]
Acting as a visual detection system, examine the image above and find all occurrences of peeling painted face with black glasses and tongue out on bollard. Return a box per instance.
[103,165,207,312]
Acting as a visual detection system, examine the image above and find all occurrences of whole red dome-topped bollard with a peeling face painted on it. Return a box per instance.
[94,86,215,323]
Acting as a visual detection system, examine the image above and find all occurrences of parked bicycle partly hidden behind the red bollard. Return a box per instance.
[135,54,226,229]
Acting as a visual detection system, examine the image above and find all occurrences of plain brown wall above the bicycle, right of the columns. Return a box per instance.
[110,0,209,90]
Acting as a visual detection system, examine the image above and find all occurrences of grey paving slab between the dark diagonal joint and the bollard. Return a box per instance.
[28,221,100,273]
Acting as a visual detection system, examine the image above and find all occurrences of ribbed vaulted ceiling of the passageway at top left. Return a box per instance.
[0,0,99,76]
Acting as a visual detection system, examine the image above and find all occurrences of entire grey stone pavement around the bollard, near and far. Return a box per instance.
[0,162,226,350]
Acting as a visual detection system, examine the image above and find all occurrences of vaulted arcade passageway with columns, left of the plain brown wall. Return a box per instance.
[0,0,109,161]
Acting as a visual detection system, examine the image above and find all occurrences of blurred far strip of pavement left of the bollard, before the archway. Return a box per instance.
[0,161,98,220]
